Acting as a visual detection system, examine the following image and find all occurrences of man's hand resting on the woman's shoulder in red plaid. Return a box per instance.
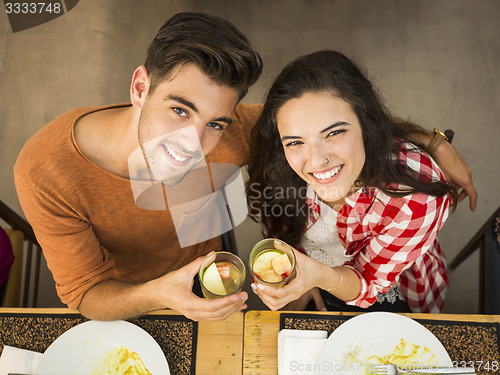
[432,142,477,211]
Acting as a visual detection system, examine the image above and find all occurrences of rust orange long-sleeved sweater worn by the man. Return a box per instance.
[14,104,261,308]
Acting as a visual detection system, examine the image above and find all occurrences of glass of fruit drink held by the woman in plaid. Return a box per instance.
[248,238,295,287]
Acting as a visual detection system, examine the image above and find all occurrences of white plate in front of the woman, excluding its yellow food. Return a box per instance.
[315,312,452,375]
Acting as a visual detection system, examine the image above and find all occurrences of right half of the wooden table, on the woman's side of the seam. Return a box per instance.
[243,311,500,375]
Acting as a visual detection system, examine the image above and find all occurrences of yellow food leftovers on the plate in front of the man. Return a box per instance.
[92,346,151,375]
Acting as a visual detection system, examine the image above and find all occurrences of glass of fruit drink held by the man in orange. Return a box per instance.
[198,251,246,299]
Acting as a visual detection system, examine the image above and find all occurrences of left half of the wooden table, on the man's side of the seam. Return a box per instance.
[0,308,244,375]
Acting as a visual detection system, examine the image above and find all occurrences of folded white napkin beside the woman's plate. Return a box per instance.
[278,329,328,375]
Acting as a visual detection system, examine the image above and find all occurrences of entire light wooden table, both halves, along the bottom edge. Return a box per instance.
[0,308,500,375]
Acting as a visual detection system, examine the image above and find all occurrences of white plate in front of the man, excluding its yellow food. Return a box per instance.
[35,320,170,375]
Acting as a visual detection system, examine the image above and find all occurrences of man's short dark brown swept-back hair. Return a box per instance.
[144,12,262,99]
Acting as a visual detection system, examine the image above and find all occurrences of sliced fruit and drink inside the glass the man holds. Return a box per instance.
[202,262,242,296]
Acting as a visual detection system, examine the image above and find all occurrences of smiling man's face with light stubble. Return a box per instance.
[139,64,239,185]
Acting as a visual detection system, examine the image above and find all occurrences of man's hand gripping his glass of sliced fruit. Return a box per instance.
[158,253,248,321]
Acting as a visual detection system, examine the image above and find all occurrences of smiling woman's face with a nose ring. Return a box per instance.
[276,92,365,208]
